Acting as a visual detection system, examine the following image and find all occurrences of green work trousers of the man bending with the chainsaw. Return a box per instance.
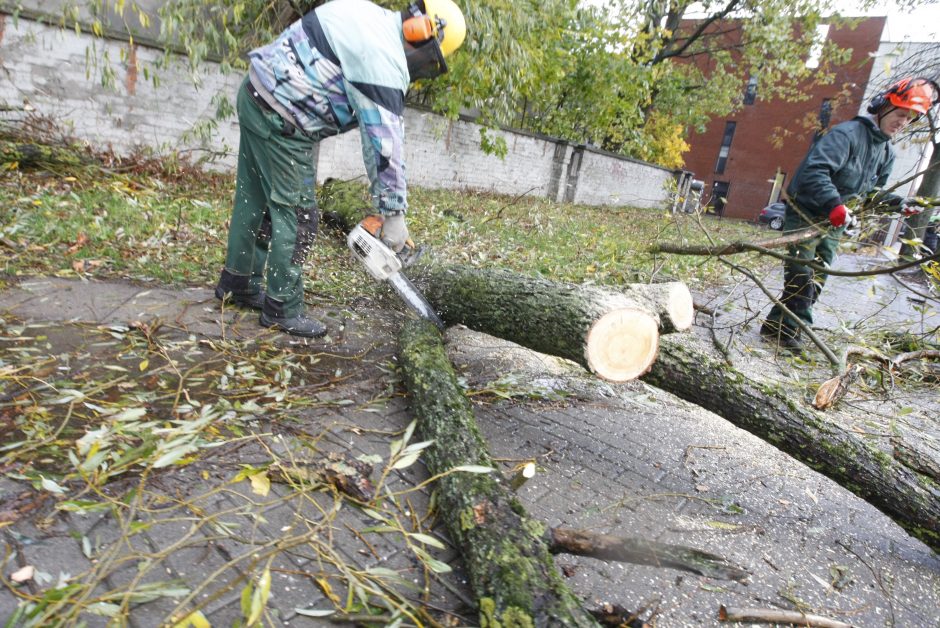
[225,78,319,317]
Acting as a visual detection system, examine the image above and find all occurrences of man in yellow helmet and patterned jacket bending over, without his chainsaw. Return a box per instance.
[215,0,466,338]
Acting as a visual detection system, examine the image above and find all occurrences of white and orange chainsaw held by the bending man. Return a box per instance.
[346,215,444,329]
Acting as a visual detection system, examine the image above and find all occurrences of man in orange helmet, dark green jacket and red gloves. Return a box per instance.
[760,78,940,350]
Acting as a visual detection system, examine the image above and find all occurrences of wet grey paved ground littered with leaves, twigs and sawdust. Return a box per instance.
[0,258,940,627]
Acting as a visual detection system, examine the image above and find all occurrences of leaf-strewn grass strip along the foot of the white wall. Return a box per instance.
[0,169,764,307]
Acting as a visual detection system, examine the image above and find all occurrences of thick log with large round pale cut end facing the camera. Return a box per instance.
[420,266,664,382]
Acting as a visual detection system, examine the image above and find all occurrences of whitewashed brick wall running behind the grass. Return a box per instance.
[0,14,674,207]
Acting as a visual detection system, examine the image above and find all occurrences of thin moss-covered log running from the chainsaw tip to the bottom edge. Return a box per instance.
[399,320,597,626]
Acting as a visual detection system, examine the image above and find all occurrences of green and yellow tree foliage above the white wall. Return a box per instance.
[75,0,860,167]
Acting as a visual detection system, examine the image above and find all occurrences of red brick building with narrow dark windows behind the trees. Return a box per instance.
[685,17,886,220]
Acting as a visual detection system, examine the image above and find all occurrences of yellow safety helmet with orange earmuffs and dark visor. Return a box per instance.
[402,0,467,80]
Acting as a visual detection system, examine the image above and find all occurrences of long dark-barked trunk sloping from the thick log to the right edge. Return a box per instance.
[644,337,940,551]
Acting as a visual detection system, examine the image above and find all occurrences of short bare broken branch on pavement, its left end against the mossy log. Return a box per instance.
[546,528,750,582]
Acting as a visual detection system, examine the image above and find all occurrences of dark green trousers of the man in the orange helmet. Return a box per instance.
[767,228,845,338]
